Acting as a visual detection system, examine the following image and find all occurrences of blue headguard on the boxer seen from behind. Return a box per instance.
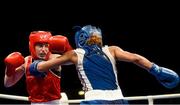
[75,25,102,48]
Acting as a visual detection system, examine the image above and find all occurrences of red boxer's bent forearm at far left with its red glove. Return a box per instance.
[4,52,25,87]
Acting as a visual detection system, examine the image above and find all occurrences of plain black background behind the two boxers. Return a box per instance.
[0,2,180,104]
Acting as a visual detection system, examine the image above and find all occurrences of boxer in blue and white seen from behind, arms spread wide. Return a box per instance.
[30,25,179,105]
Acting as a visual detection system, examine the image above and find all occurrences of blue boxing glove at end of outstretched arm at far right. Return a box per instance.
[149,64,179,89]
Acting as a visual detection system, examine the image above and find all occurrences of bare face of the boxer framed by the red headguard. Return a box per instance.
[35,43,49,59]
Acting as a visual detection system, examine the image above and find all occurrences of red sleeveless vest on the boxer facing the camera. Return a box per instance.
[26,56,61,102]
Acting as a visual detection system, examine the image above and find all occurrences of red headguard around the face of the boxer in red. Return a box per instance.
[29,31,52,60]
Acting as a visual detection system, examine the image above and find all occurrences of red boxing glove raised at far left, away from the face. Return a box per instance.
[4,52,25,76]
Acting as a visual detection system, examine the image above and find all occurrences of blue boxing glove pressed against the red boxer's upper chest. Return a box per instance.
[29,60,47,77]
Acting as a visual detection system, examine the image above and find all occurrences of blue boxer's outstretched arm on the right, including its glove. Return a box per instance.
[112,47,179,89]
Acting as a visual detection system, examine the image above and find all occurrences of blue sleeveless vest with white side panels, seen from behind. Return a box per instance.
[75,45,119,91]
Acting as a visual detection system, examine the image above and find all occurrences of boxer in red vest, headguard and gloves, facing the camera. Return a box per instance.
[4,31,72,105]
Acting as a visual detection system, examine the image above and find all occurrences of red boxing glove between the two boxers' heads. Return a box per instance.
[49,35,72,54]
